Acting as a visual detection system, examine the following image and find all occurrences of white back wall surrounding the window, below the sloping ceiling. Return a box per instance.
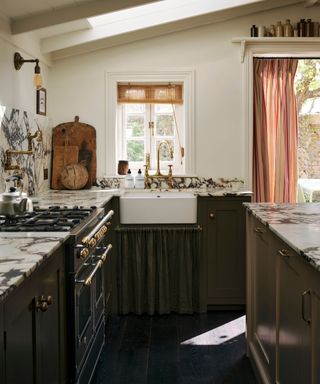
[5,6,320,183]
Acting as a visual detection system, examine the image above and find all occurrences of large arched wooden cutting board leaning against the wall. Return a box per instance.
[51,116,97,189]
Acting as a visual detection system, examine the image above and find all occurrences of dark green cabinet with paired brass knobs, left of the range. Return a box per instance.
[1,251,65,384]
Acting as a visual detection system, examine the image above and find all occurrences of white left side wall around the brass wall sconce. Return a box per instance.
[0,16,50,113]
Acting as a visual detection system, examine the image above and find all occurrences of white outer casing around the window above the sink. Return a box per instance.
[105,68,196,176]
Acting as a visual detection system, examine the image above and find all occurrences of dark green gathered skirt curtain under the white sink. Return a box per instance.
[117,226,201,315]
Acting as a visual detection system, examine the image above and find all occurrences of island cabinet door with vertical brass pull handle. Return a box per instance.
[277,243,311,384]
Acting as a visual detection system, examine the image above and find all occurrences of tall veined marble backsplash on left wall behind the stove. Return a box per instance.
[0,106,52,196]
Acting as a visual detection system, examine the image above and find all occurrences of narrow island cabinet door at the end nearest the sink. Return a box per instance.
[252,220,276,382]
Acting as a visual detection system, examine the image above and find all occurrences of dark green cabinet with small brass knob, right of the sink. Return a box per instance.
[198,196,250,307]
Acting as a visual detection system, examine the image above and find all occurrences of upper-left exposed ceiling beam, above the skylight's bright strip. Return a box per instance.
[11,0,161,34]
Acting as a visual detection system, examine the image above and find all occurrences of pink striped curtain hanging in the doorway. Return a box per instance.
[253,58,298,203]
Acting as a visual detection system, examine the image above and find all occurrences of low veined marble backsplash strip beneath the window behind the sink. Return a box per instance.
[96,176,244,190]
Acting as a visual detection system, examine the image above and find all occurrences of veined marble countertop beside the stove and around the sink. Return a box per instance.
[0,188,250,301]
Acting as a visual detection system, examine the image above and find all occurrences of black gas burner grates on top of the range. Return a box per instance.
[0,206,96,232]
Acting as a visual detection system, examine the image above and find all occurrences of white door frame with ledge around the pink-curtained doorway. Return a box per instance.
[239,38,320,189]
